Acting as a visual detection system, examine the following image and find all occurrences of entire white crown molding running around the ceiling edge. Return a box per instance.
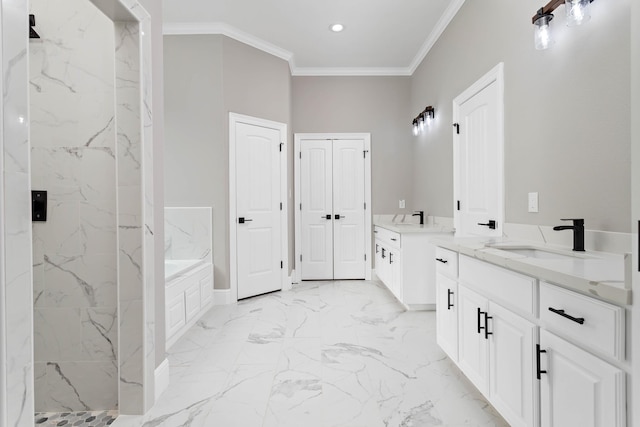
[163,0,465,76]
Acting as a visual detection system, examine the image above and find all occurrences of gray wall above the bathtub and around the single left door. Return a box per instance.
[165,35,293,289]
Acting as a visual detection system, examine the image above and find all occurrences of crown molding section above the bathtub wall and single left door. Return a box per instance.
[162,22,293,63]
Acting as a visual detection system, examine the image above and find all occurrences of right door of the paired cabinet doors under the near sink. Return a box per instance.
[488,302,538,427]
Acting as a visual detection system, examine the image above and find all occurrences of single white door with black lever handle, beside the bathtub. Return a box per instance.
[232,123,283,299]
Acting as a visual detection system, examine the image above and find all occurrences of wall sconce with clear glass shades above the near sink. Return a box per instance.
[531,0,593,50]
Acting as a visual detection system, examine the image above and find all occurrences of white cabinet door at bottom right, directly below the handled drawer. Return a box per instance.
[540,329,626,427]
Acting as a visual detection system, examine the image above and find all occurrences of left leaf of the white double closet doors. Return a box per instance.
[300,140,333,280]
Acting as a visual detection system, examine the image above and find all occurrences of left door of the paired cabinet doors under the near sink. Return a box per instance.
[458,284,489,395]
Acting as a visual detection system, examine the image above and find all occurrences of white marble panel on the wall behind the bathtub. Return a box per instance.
[164,207,213,262]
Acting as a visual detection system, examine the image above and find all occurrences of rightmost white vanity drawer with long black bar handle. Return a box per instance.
[540,282,625,360]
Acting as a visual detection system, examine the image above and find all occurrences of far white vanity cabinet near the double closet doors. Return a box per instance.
[374,226,436,310]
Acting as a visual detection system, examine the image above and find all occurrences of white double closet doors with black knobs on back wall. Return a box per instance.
[299,139,367,280]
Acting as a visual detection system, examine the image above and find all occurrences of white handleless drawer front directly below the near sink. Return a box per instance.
[460,255,537,316]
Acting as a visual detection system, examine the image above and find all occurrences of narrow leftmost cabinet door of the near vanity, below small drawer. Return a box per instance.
[436,273,458,362]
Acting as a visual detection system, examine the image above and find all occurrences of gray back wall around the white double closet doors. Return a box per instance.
[293,77,412,214]
